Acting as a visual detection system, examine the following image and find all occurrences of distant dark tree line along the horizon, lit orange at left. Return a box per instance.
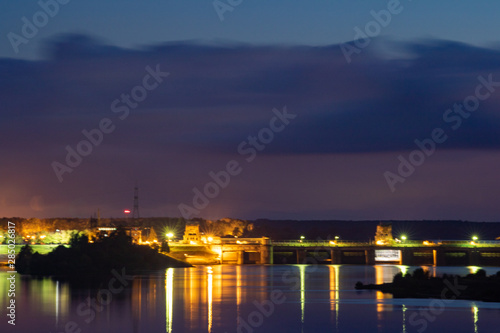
[0,217,500,244]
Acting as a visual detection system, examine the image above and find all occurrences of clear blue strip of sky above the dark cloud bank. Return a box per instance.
[0,0,500,58]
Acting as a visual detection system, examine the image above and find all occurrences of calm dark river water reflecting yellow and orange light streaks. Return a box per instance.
[0,265,500,333]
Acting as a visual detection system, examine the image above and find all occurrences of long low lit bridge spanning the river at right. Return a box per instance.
[169,237,500,266]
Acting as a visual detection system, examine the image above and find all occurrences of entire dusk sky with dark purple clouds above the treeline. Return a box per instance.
[0,0,500,221]
